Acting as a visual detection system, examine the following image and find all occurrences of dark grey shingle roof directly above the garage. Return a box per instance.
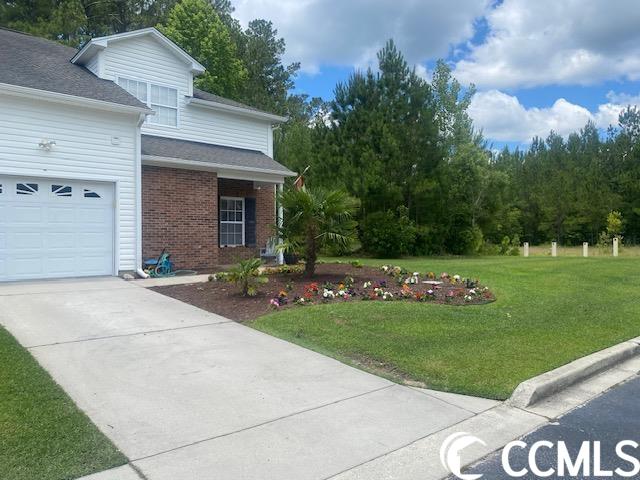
[0,28,147,108]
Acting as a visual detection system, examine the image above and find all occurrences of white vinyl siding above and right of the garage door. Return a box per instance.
[0,95,138,270]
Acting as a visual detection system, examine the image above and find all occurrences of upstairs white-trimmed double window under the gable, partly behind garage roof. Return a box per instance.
[118,77,178,127]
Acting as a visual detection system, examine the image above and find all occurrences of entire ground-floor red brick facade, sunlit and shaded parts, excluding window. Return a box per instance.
[142,166,276,271]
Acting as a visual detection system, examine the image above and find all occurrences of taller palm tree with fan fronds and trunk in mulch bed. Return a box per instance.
[278,187,358,277]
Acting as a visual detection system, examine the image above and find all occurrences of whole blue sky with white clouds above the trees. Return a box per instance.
[235,0,640,147]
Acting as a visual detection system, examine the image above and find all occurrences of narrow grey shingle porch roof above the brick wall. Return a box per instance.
[142,135,293,175]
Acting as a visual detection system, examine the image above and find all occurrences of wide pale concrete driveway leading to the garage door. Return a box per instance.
[0,278,495,480]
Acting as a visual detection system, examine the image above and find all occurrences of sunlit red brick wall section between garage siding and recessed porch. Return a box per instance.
[142,166,218,270]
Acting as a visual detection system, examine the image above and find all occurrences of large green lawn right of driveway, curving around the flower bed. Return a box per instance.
[252,257,640,399]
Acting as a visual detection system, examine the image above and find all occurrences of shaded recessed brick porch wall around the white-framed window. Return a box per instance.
[218,178,276,265]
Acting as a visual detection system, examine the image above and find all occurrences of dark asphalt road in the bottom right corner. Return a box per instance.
[465,376,640,480]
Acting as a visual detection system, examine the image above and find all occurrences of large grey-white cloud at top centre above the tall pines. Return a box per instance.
[234,0,490,73]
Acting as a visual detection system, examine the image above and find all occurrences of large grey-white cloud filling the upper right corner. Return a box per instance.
[456,0,640,88]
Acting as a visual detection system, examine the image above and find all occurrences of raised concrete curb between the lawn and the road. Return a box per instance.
[505,337,640,408]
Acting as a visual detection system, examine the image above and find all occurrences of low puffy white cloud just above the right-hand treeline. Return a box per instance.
[469,90,640,143]
